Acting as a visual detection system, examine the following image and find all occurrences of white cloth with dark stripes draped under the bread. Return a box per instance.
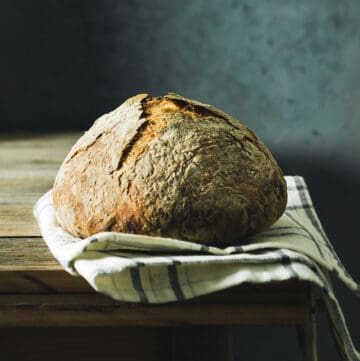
[34,176,360,360]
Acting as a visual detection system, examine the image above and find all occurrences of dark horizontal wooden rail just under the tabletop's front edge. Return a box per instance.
[0,294,307,327]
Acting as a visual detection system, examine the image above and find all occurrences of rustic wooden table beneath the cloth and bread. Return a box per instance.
[0,133,315,360]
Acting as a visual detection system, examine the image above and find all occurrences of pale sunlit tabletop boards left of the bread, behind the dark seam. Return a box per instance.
[0,133,79,237]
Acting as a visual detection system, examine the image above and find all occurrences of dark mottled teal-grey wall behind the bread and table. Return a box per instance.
[0,0,360,360]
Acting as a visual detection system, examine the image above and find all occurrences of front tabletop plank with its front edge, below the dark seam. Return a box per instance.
[0,233,306,303]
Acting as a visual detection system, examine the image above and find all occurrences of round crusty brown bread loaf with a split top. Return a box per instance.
[53,93,287,246]
